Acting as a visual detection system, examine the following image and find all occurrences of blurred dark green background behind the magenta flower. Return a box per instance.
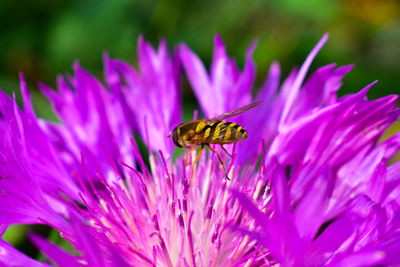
[0,0,400,262]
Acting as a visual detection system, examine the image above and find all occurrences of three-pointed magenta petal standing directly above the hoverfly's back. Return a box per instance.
[179,35,255,118]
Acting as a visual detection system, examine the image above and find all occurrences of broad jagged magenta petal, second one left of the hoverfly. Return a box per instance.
[41,63,134,182]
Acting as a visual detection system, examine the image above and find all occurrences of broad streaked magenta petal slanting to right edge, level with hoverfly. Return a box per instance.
[269,80,398,168]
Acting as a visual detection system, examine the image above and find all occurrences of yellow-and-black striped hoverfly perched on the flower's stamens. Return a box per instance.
[172,102,261,179]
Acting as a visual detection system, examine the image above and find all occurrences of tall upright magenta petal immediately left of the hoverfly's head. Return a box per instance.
[105,37,181,157]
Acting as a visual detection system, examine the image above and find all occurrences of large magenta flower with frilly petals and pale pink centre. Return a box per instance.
[0,35,400,266]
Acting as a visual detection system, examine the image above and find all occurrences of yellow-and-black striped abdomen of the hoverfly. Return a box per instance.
[196,121,247,144]
